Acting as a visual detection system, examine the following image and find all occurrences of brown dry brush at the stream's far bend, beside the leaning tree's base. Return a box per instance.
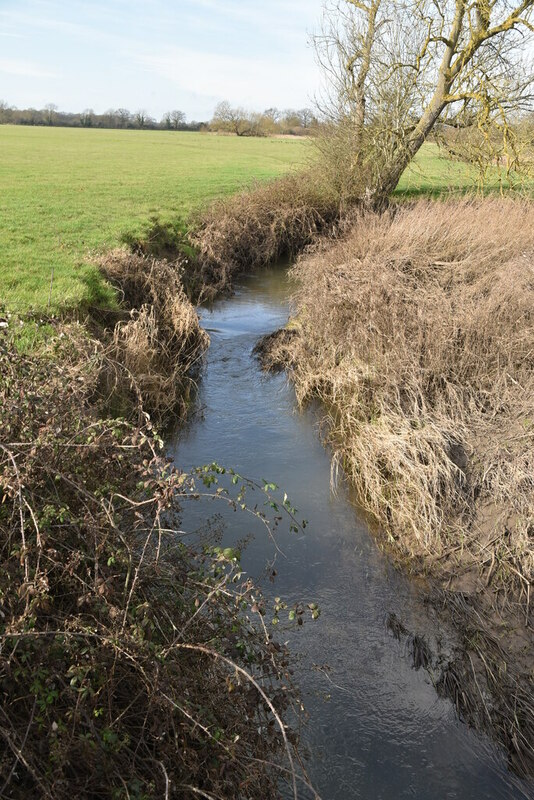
[192,171,339,294]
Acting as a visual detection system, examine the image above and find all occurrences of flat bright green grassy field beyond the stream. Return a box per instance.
[0,125,532,313]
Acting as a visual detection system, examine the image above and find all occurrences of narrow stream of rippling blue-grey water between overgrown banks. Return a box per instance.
[170,268,534,800]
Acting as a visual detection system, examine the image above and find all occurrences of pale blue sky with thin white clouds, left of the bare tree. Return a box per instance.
[0,0,322,121]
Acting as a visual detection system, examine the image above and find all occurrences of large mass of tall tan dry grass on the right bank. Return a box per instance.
[291,199,534,596]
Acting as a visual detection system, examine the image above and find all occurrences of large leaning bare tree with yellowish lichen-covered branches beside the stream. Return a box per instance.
[315,0,534,204]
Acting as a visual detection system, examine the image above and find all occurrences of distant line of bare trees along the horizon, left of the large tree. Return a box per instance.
[0,100,319,136]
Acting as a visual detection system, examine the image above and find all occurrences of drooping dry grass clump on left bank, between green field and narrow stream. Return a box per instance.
[100,250,209,417]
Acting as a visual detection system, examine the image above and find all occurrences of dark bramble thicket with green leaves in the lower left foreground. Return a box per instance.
[0,325,308,800]
